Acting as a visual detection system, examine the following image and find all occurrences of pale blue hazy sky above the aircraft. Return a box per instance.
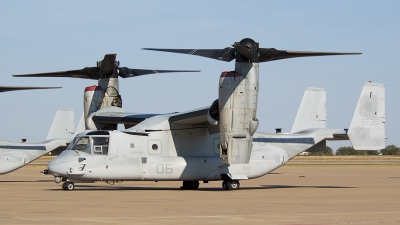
[0,0,400,149]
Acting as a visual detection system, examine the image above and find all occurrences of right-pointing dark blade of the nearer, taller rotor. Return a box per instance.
[259,48,362,62]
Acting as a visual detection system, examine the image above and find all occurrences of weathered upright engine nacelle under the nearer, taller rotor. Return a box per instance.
[219,67,259,164]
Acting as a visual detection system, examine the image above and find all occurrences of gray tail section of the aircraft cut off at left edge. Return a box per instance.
[0,109,75,174]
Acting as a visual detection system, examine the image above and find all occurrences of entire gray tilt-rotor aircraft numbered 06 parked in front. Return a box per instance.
[14,39,385,190]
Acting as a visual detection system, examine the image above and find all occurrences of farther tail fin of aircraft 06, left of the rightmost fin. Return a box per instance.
[290,88,326,133]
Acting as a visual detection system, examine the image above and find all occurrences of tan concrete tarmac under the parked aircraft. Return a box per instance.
[0,165,400,225]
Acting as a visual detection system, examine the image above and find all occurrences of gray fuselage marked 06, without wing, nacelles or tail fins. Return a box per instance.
[49,125,318,182]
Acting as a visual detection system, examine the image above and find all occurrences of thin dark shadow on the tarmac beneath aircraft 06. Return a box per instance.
[48,185,358,191]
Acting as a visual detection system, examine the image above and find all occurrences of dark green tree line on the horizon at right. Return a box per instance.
[308,145,400,156]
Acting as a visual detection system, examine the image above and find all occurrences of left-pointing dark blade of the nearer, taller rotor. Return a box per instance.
[142,47,235,62]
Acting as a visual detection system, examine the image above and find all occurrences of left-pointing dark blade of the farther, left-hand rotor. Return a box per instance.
[13,67,99,80]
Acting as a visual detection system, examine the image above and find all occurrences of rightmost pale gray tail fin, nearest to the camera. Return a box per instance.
[347,83,386,150]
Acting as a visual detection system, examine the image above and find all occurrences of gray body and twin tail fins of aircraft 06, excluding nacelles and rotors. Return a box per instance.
[43,83,385,190]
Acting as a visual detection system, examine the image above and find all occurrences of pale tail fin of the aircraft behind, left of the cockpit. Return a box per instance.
[46,109,75,140]
